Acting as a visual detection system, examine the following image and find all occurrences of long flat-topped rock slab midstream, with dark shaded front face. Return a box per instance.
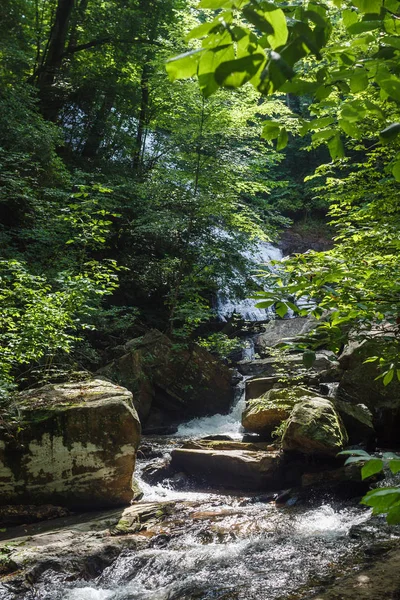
[171,448,282,490]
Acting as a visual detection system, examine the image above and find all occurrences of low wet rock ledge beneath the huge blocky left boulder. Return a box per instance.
[0,502,175,598]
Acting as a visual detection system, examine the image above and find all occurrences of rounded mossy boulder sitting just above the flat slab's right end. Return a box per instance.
[282,397,348,456]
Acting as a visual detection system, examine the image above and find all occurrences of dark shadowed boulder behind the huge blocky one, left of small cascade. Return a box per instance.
[101,330,233,425]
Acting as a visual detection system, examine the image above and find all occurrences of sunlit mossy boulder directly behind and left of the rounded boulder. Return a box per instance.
[242,386,318,435]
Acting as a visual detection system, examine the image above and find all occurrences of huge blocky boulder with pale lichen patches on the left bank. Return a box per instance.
[0,380,140,509]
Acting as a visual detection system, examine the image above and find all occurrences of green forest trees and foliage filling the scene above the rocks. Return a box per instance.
[0,0,400,394]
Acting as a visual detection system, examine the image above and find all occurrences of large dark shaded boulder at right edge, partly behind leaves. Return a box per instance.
[337,332,400,446]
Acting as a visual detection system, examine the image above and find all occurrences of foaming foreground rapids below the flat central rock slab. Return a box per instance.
[32,498,374,600]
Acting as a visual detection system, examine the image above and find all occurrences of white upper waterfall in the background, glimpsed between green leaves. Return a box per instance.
[217,242,283,323]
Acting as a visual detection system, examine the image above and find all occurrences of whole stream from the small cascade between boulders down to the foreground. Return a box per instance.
[21,382,398,600]
